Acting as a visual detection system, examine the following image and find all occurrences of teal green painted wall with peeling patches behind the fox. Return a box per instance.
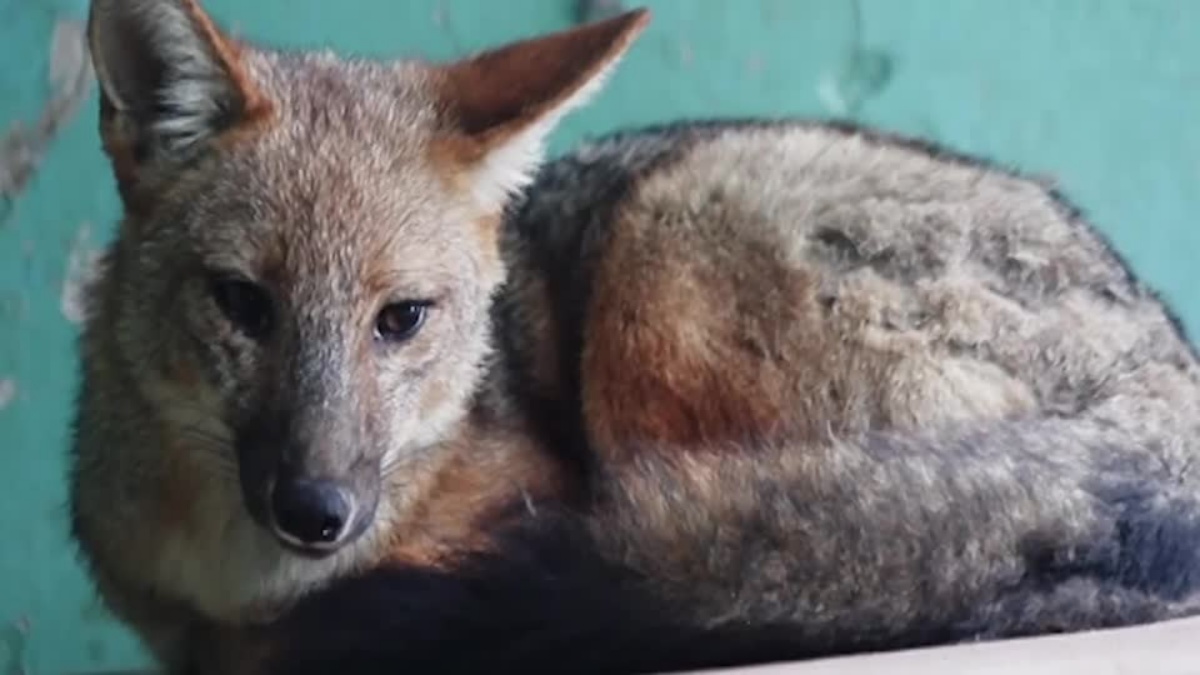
[0,0,1200,675]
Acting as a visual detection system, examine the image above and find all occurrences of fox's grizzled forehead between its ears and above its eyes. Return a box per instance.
[175,53,487,285]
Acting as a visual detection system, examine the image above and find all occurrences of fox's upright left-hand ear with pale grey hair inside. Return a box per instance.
[88,0,268,192]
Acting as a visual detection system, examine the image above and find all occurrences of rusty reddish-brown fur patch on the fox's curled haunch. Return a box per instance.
[582,201,889,460]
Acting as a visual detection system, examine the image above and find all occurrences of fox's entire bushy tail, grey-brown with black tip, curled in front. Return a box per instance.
[267,408,1200,675]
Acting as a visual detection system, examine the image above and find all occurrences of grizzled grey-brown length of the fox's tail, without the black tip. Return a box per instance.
[596,410,1200,646]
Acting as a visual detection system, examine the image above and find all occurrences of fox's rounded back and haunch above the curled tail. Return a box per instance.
[508,121,1200,464]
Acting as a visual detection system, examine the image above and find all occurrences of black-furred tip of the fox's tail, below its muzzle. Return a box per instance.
[268,504,949,675]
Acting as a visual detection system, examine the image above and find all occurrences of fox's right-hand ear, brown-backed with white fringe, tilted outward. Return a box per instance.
[434,10,650,209]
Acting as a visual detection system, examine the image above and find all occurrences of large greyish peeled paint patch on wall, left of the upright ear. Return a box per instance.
[0,18,91,222]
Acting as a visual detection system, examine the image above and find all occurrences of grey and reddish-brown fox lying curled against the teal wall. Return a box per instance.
[68,0,1200,675]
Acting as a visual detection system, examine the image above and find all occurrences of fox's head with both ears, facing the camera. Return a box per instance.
[89,0,648,555]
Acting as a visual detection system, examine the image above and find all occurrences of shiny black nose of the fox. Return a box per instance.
[271,479,354,549]
